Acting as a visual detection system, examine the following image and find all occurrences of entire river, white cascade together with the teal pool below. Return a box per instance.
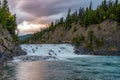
[0,44,120,80]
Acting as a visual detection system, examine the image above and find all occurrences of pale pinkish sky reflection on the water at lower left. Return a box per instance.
[16,62,44,80]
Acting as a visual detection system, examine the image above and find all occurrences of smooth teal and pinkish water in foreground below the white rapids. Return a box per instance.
[0,56,120,80]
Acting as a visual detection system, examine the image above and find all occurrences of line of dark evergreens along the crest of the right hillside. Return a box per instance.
[21,0,120,45]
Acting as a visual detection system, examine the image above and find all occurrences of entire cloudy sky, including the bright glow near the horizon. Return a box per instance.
[8,0,102,35]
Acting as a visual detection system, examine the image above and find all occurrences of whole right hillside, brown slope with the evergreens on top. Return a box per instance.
[24,0,120,52]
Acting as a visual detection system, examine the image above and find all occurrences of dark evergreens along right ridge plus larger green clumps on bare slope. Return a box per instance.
[23,0,120,44]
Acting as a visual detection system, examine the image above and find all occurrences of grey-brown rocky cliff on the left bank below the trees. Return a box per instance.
[0,25,24,63]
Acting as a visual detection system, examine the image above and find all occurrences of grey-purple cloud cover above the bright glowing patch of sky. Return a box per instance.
[8,0,101,23]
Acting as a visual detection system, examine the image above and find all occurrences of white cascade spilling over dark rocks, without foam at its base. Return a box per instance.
[21,44,75,57]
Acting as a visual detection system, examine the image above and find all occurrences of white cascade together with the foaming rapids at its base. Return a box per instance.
[14,44,92,62]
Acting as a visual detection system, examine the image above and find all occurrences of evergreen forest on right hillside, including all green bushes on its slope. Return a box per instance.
[21,0,120,48]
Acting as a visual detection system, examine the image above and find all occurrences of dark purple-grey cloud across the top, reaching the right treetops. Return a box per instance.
[21,0,100,17]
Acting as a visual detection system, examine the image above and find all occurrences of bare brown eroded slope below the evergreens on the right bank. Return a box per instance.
[24,20,120,51]
